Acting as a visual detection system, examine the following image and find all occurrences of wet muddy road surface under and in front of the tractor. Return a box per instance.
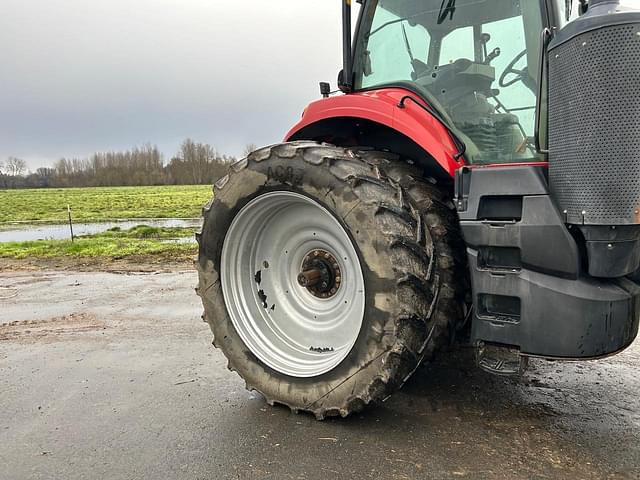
[0,272,640,480]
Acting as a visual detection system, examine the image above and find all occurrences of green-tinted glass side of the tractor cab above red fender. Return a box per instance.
[354,0,547,163]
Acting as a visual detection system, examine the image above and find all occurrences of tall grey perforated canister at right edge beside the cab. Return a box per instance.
[548,0,640,277]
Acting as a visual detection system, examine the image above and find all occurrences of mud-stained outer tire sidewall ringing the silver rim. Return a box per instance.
[199,153,397,408]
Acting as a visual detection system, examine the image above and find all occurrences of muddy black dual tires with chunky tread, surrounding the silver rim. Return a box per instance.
[197,142,464,419]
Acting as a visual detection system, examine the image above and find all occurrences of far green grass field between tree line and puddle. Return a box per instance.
[0,185,211,222]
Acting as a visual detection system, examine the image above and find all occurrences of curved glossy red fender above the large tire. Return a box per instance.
[285,88,464,177]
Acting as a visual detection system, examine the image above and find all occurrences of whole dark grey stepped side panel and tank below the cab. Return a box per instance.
[456,166,640,358]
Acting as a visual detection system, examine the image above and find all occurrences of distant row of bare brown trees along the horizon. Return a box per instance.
[0,139,255,188]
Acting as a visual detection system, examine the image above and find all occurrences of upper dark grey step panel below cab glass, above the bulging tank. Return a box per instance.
[456,167,580,278]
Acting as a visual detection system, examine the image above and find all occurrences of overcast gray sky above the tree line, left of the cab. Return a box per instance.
[0,0,356,169]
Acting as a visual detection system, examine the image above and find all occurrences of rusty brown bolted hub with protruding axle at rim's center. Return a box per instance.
[298,249,342,298]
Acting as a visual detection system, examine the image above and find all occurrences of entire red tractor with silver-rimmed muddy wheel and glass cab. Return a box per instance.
[198,0,640,419]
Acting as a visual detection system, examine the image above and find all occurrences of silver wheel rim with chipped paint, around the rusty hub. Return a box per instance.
[220,191,365,377]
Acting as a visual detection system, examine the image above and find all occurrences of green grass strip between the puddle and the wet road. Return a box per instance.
[0,225,197,260]
